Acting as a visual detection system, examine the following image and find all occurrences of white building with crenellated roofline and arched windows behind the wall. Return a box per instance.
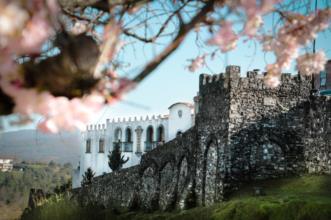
[72,102,195,188]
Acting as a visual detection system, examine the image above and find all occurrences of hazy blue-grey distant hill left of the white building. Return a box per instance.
[0,130,81,166]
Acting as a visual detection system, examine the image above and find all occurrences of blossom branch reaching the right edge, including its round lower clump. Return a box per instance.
[262,9,331,87]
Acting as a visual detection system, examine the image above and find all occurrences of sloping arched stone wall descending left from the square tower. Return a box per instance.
[76,128,196,210]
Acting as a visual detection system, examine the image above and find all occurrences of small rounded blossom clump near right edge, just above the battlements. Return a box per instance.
[296,51,327,76]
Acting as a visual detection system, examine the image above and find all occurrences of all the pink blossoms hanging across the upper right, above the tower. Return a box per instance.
[189,0,331,88]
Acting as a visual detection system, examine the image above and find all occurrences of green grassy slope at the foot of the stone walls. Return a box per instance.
[23,176,331,220]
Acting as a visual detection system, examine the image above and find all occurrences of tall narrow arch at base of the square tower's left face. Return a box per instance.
[202,135,219,205]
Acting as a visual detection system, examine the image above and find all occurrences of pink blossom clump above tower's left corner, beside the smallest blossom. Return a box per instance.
[208,21,238,52]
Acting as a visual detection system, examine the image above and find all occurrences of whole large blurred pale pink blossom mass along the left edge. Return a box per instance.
[0,0,104,132]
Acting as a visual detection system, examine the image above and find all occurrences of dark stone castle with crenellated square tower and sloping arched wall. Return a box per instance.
[75,66,331,210]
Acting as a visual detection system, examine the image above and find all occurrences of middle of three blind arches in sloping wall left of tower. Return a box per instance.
[159,162,177,211]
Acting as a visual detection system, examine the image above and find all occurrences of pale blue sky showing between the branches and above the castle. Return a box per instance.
[2,1,331,129]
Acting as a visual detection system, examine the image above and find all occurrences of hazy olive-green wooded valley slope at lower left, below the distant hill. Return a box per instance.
[0,162,72,220]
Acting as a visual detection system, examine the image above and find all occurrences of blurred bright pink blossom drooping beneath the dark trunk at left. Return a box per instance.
[0,71,105,132]
